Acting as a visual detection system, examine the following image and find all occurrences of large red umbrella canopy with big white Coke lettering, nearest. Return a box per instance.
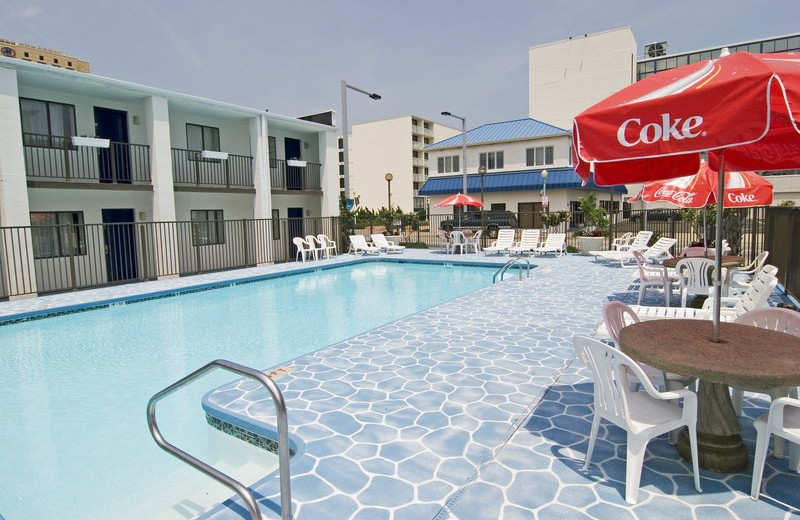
[573,52,800,186]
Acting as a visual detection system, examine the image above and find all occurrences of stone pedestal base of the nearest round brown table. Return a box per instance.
[678,379,747,473]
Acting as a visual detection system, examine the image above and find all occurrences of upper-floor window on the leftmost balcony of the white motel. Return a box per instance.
[19,98,77,148]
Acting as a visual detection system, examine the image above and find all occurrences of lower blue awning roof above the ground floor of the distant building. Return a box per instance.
[419,167,628,196]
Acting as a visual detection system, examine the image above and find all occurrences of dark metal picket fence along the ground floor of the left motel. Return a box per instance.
[0,217,346,298]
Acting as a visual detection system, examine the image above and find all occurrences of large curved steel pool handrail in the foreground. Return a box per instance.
[147,359,292,520]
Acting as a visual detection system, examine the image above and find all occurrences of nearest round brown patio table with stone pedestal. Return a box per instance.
[619,320,800,473]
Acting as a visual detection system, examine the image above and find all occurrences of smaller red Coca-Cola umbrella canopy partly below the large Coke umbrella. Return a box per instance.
[630,162,772,208]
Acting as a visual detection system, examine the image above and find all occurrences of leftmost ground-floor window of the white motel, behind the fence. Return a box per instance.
[31,211,86,258]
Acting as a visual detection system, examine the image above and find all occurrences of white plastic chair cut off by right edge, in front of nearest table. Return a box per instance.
[750,397,800,500]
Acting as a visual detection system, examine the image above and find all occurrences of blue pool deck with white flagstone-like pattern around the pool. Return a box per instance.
[0,250,800,520]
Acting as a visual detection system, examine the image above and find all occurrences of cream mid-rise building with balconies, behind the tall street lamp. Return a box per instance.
[339,115,460,212]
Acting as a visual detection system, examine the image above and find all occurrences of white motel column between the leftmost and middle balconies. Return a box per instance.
[144,96,181,278]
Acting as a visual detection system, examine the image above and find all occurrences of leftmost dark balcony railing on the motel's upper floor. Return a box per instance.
[22,132,150,184]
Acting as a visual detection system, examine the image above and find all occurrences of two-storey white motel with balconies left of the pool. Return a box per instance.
[0,58,339,296]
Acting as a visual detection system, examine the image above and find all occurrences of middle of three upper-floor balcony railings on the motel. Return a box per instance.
[172,148,253,188]
